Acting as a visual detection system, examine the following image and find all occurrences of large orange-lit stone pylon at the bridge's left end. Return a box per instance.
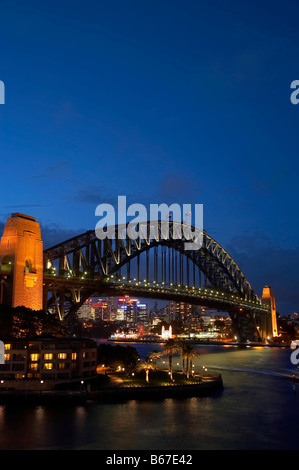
[0,213,43,310]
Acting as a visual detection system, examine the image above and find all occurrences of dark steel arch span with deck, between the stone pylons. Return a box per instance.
[44,221,269,341]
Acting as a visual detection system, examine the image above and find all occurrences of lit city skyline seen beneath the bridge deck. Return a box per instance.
[77,295,234,341]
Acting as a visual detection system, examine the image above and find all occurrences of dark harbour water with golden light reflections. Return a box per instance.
[0,343,299,451]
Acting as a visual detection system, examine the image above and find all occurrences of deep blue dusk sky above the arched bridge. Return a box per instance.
[0,0,299,314]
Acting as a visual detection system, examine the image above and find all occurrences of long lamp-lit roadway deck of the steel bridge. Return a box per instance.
[0,273,270,343]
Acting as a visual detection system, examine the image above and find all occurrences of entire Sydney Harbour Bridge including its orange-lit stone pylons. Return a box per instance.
[0,214,277,342]
